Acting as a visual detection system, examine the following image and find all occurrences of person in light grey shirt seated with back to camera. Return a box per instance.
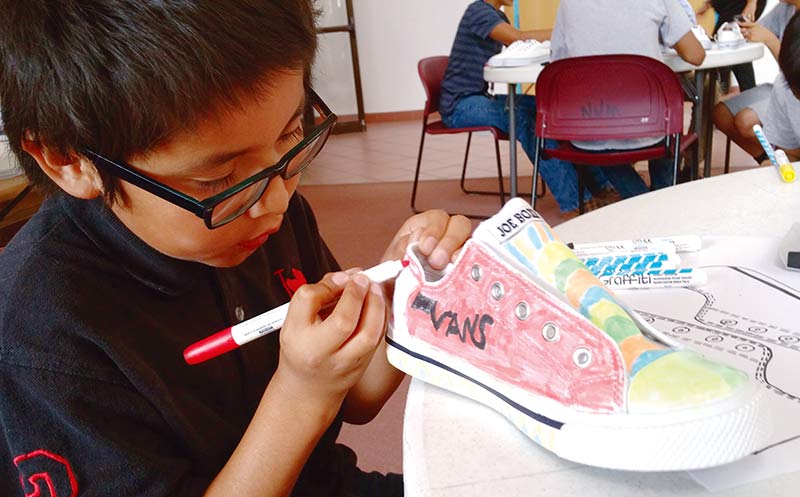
[550,0,705,198]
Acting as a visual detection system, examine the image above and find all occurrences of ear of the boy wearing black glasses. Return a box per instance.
[22,133,103,200]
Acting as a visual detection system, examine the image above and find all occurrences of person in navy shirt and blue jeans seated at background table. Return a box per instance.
[439,0,606,212]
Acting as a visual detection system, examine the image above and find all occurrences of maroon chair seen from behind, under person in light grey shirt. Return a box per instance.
[531,54,697,213]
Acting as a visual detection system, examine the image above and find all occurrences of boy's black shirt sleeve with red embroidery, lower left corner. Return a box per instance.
[0,361,213,497]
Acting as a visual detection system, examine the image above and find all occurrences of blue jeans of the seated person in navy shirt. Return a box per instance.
[442,95,608,212]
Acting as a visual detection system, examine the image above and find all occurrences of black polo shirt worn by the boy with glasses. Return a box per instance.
[0,194,354,497]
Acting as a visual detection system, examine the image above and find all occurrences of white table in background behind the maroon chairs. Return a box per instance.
[483,43,764,197]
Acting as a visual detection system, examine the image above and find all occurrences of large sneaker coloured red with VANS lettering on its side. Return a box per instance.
[386,198,773,471]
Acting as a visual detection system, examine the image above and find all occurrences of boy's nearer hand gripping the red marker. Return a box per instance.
[275,272,386,410]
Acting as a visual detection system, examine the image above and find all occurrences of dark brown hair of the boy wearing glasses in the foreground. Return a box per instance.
[0,0,317,200]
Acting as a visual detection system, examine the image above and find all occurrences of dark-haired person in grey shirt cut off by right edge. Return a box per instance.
[761,14,800,161]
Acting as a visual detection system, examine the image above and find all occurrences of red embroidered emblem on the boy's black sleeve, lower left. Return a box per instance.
[14,449,78,497]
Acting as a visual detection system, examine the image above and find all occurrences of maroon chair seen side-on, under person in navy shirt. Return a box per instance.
[411,55,508,217]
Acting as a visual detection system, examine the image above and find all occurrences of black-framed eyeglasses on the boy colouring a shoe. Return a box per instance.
[82,90,338,229]
